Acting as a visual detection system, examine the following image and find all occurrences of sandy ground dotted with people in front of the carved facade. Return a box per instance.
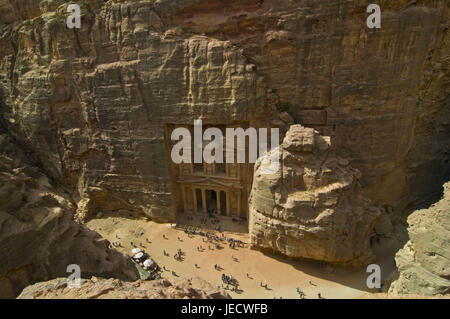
[87,215,382,299]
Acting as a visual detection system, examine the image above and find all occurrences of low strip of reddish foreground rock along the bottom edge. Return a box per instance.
[17,277,231,299]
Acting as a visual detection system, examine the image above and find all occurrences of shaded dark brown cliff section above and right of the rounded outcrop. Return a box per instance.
[163,0,450,212]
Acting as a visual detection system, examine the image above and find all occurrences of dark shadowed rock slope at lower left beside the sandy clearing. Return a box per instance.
[0,132,138,298]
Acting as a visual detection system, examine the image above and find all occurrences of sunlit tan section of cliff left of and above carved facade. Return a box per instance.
[2,2,275,220]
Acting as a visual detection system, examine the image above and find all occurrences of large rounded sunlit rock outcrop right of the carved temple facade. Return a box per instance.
[249,125,381,265]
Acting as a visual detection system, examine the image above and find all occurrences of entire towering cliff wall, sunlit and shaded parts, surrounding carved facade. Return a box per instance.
[0,0,450,225]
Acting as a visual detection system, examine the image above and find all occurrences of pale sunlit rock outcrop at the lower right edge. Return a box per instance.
[389,182,450,295]
